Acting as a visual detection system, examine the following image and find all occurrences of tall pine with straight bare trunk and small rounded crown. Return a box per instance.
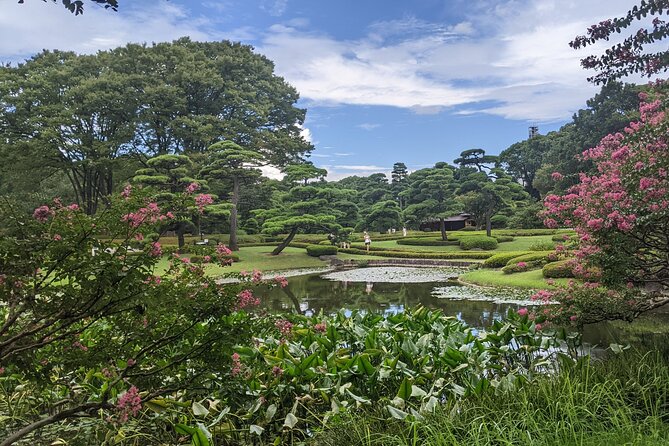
[200,141,264,251]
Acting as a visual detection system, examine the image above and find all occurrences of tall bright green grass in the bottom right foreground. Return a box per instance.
[314,352,669,446]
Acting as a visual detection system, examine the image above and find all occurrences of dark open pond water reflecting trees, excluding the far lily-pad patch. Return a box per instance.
[259,274,669,354]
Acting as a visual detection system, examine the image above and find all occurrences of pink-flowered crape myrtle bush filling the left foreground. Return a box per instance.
[0,189,284,446]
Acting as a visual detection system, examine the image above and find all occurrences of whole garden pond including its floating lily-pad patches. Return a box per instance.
[259,267,669,345]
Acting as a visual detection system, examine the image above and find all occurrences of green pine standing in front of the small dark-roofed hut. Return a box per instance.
[403,163,462,240]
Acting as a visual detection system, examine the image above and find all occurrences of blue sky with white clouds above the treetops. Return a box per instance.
[0,0,634,179]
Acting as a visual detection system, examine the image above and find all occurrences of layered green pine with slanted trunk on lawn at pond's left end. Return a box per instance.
[256,164,343,255]
